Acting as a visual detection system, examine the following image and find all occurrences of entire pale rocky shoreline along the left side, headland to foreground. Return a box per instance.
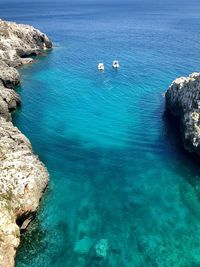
[0,20,52,267]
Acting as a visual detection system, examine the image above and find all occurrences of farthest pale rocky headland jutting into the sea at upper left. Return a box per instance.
[0,20,52,67]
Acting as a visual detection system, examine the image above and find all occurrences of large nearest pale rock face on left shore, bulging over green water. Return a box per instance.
[0,118,48,267]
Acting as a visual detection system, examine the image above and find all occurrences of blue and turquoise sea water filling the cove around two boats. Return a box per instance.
[0,0,200,267]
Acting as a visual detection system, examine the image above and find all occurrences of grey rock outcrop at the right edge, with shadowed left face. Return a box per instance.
[165,73,200,155]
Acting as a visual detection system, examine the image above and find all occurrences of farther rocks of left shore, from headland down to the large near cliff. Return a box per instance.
[0,20,52,120]
